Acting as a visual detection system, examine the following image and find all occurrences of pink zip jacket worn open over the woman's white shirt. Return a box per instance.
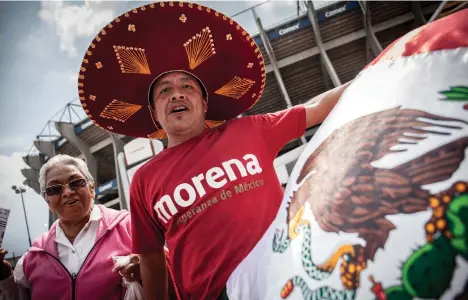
[23,205,131,300]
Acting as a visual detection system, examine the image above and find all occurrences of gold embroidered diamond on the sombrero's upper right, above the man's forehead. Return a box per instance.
[184,27,216,70]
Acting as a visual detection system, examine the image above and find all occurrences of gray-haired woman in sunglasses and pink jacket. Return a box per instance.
[0,155,179,300]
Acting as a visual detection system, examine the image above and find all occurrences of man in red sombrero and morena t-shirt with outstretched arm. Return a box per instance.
[78,2,345,300]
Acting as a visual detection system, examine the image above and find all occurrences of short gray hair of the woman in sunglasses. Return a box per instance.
[39,154,94,191]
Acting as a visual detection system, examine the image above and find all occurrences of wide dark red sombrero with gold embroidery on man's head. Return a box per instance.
[78,2,265,139]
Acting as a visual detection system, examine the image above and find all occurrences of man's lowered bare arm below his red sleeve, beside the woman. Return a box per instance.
[140,249,169,300]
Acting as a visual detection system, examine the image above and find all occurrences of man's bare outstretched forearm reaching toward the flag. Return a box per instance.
[304,81,351,128]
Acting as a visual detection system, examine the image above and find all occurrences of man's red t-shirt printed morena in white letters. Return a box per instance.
[130,106,305,299]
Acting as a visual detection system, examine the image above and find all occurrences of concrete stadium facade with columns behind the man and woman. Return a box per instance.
[22,1,466,224]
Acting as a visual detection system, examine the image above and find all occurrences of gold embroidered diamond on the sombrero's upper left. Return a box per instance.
[114,46,151,74]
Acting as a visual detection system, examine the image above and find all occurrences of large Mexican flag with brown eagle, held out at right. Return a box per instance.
[227,9,468,300]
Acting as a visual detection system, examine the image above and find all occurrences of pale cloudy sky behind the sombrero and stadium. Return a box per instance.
[0,0,324,257]
